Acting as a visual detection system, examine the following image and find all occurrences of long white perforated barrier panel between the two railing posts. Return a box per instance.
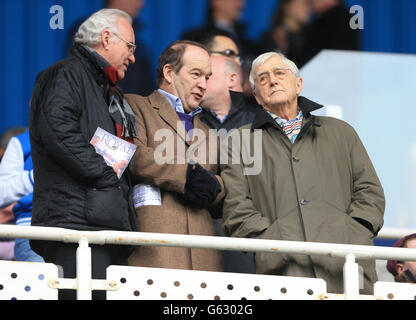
[107,266,326,300]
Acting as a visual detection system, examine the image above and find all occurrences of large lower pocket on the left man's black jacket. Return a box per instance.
[85,187,129,230]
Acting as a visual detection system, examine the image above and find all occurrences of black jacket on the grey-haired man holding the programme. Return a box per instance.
[29,45,137,231]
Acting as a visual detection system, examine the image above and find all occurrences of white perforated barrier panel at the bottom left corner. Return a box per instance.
[0,261,58,300]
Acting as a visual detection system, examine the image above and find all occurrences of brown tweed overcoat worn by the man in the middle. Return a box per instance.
[126,91,225,271]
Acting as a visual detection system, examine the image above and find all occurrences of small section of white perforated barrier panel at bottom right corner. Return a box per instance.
[374,281,416,300]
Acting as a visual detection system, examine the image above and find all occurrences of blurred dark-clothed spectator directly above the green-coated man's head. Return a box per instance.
[260,0,311,65]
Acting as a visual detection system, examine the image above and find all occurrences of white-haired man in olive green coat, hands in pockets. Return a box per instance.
[221,52,385,294]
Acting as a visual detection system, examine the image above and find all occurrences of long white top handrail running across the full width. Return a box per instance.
[0,225,416,261]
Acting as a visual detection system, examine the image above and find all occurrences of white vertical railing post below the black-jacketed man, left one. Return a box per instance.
[77,238,92,300]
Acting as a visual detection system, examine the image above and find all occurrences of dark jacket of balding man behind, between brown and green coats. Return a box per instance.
[198,91,259,132]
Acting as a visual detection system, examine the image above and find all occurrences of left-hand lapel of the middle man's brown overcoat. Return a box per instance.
[149,90,189,146]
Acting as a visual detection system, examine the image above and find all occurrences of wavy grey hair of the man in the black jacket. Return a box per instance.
[74,9,133,47]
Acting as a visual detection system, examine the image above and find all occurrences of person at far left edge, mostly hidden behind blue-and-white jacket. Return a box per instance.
[0,127,27,260]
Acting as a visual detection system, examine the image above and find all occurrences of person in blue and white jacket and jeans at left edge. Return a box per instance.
[0,130,44,262]
